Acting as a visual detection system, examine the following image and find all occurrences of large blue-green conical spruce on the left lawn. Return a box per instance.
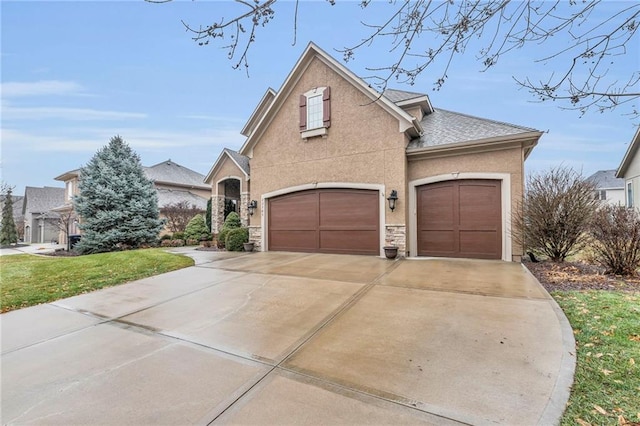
[74,136,163,254]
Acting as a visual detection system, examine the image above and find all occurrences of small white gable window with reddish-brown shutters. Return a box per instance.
[300,87,331,138]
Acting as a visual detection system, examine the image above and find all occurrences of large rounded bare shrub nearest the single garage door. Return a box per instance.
[513,166,598,262]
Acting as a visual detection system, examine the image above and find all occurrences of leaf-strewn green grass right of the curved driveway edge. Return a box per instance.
[552,291,640,425]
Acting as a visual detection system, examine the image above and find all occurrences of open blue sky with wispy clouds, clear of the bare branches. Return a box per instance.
[0,0,640,195]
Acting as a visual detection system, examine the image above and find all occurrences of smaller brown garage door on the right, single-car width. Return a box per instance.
[417,180,502,259]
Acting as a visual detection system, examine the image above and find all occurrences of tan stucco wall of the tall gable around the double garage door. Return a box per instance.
[251,59,406,230]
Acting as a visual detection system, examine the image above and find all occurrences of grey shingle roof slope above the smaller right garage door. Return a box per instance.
[407,109,537,149]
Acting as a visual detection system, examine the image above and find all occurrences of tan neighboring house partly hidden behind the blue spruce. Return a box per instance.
[54,160,211,239]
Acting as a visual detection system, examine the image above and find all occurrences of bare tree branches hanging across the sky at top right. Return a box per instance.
[156,0,640,117]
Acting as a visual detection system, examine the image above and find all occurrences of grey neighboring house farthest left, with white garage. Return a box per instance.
[22,186,65,244]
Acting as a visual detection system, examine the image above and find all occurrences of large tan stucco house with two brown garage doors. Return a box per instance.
[206,43,542,261]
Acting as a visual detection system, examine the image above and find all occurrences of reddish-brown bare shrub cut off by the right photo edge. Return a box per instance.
[591,205,640,275]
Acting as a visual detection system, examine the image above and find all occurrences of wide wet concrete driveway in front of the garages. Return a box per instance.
[1,252,574,425]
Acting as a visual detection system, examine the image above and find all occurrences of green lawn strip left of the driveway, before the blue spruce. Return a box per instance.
[0,249,194,312]
